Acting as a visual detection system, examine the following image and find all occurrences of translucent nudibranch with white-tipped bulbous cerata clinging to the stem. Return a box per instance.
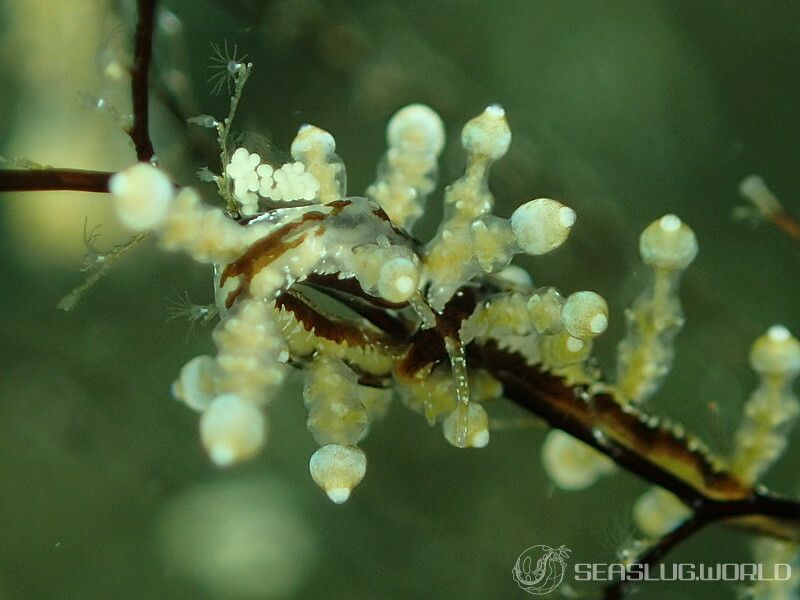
[111,104,608,502]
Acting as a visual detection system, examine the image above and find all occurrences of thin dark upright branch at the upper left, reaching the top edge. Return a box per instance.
[128,0,156,162]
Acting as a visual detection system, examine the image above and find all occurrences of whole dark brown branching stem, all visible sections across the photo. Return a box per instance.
[0,0,800,599]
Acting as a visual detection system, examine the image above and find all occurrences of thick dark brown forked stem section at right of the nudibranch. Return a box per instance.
[470,343,800,600]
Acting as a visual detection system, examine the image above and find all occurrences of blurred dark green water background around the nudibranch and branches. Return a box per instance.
[0,0,800,600]
